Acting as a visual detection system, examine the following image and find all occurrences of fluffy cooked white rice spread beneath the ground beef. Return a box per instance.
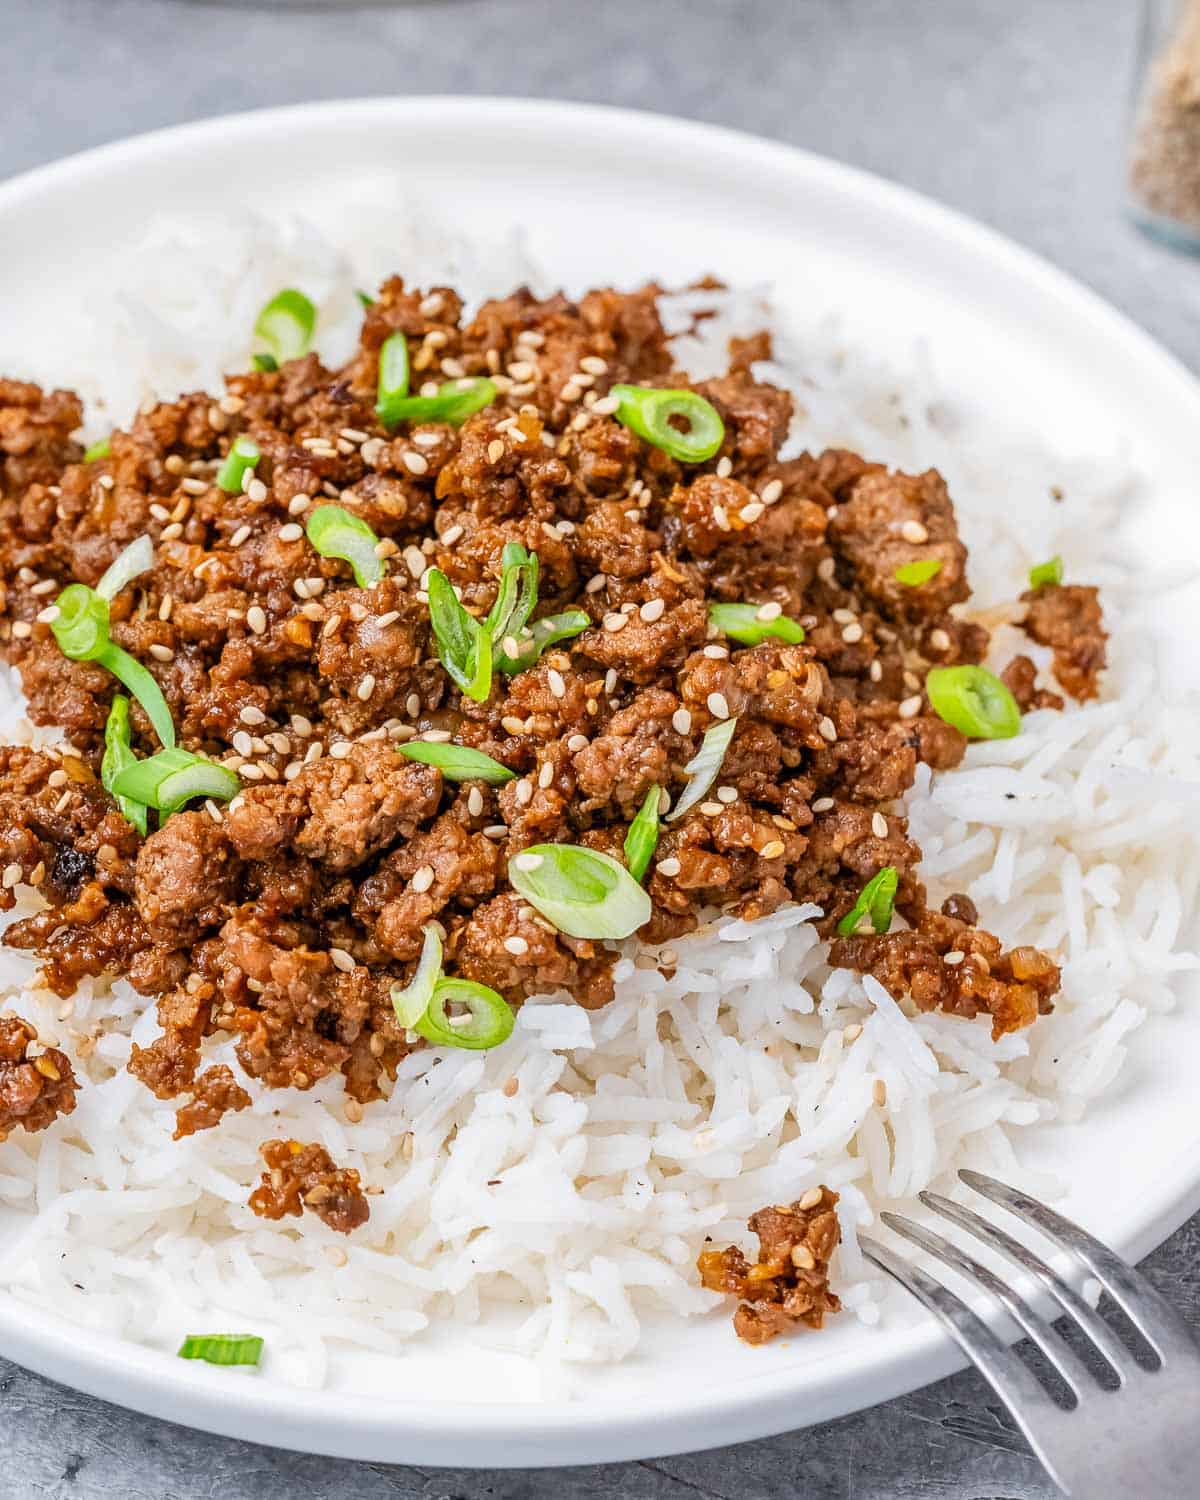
[0,221,1200,1386]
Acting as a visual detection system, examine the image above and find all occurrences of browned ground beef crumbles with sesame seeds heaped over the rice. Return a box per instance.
[0,279,1104,1254]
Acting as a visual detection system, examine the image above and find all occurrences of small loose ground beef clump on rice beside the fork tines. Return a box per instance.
[698,1187,842,1344]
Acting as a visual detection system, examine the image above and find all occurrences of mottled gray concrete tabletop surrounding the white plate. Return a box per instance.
[0,0,1200,1500]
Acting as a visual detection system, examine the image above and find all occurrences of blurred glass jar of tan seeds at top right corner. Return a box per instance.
[1128,0,1200,254]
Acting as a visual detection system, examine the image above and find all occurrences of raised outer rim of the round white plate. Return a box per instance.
[0,95,1200,1469]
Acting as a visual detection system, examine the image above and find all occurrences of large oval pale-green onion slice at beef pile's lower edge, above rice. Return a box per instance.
[509,845,650,939]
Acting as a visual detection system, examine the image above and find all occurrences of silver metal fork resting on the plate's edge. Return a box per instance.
[860,1172,1200,1500]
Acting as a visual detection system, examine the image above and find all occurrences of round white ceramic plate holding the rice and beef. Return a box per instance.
[0,99,1200,1466]
